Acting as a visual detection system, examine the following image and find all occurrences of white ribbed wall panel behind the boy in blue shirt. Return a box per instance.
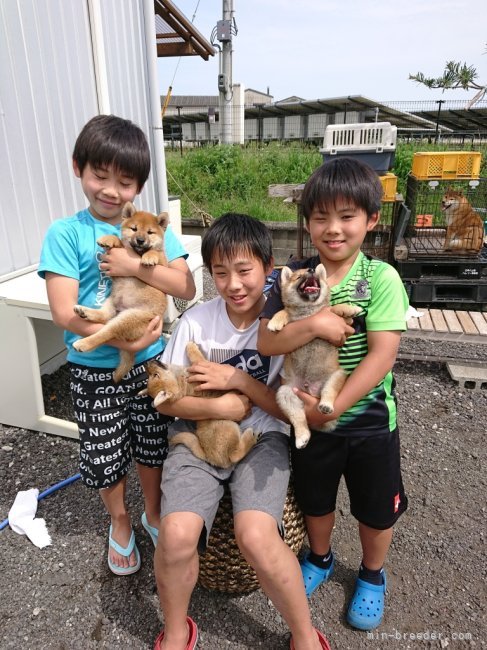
[0,0,98,276]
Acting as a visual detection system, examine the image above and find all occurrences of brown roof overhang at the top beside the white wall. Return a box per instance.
[154,0,215,61]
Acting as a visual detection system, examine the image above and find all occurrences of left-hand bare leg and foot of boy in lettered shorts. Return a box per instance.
[100,475,137,568]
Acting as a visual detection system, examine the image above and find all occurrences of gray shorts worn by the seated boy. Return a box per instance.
[161,431,290,550]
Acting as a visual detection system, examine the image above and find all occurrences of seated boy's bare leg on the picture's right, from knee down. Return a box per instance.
[235,510,321,650]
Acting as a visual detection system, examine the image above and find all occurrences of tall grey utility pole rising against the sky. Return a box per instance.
[216,0,237,144]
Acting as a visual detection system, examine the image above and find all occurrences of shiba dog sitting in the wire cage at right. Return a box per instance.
[441,190,484,252]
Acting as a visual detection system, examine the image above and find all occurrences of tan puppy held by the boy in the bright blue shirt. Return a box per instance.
[73,203,169,382]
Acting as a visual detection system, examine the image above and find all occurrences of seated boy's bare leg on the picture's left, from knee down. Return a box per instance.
[154,512,204,650]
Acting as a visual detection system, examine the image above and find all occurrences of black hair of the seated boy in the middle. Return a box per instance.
[201,212,272,273]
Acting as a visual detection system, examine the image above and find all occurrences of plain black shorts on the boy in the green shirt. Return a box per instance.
[291,429,408,530]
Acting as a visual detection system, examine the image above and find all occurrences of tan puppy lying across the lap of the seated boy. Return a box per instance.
[141,341,258,467]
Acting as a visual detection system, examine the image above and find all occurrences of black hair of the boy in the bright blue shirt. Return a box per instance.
[73,115,150,192]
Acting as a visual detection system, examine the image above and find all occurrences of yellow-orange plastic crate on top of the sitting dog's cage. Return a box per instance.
[411,151,482,181]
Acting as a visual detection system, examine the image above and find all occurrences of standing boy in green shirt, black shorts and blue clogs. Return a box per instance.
[258,158,408,630]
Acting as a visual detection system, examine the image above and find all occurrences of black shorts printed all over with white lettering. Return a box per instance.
[69,356,173,489]
